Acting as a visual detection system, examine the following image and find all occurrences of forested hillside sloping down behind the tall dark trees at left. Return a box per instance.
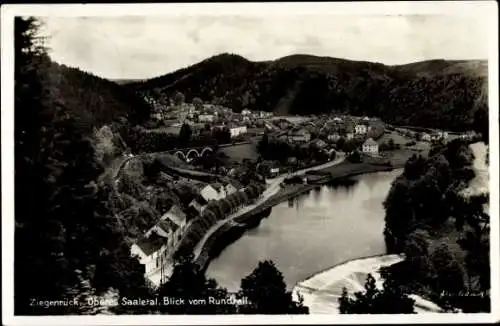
[42,59,151,134]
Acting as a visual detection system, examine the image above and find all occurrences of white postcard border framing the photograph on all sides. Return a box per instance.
[1,1,500,325]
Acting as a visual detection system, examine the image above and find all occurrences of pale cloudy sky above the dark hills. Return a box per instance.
[38,14,489,79]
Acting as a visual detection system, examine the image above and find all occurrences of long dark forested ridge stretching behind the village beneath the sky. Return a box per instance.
[127,54,487,134]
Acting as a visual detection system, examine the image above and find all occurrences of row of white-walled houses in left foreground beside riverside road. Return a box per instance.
[130,182,241,286]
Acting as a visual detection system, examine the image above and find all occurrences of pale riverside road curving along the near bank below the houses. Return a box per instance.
[193,156,345,259]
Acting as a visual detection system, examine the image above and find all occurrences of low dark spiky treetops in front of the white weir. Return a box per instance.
[339,274,415,314]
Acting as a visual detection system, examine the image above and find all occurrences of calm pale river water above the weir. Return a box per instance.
[206,169,402,291]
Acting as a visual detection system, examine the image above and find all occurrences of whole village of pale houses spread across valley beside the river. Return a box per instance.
[124,92,477,287]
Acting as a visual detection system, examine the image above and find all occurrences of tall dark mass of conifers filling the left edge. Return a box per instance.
[14,18,152,315]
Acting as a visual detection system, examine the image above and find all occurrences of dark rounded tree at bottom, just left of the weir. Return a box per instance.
[238,260,309,314]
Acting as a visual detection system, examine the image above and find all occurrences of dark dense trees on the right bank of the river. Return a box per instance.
[384,140,490,312]
